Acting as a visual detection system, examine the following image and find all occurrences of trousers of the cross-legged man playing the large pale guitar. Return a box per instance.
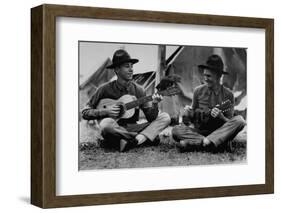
[100,112,171,148]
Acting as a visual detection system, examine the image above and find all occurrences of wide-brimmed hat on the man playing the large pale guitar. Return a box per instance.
[106,49,139,69]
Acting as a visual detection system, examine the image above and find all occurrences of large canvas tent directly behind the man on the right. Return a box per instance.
[162,46,246,117]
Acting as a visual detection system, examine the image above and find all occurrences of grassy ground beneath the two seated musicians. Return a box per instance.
[79,121,246,170]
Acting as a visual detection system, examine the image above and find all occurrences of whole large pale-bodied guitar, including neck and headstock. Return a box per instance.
[97,87,181,120]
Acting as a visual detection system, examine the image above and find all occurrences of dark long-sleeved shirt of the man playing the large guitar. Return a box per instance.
[82,80,158,125]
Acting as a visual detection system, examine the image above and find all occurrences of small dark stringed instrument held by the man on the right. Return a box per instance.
[183,99,232,126]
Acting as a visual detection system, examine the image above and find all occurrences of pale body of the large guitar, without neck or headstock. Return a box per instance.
[97,95,136,120]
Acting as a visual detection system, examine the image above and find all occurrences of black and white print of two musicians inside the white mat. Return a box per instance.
[78,41,247,170]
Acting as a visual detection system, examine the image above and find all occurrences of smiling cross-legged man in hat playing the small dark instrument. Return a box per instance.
[172,55,246,151]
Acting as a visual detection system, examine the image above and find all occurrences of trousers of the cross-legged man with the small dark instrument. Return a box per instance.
[172,115,246,146]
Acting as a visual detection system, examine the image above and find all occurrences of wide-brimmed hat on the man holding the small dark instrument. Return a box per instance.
[198,55,228,74]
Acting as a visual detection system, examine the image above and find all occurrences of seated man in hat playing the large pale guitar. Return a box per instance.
[82,49,170,152]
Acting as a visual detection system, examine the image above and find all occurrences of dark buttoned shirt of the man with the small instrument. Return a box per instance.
[189,84,234,131]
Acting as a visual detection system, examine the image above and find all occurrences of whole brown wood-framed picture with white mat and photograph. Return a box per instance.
[30,4,275,209]
